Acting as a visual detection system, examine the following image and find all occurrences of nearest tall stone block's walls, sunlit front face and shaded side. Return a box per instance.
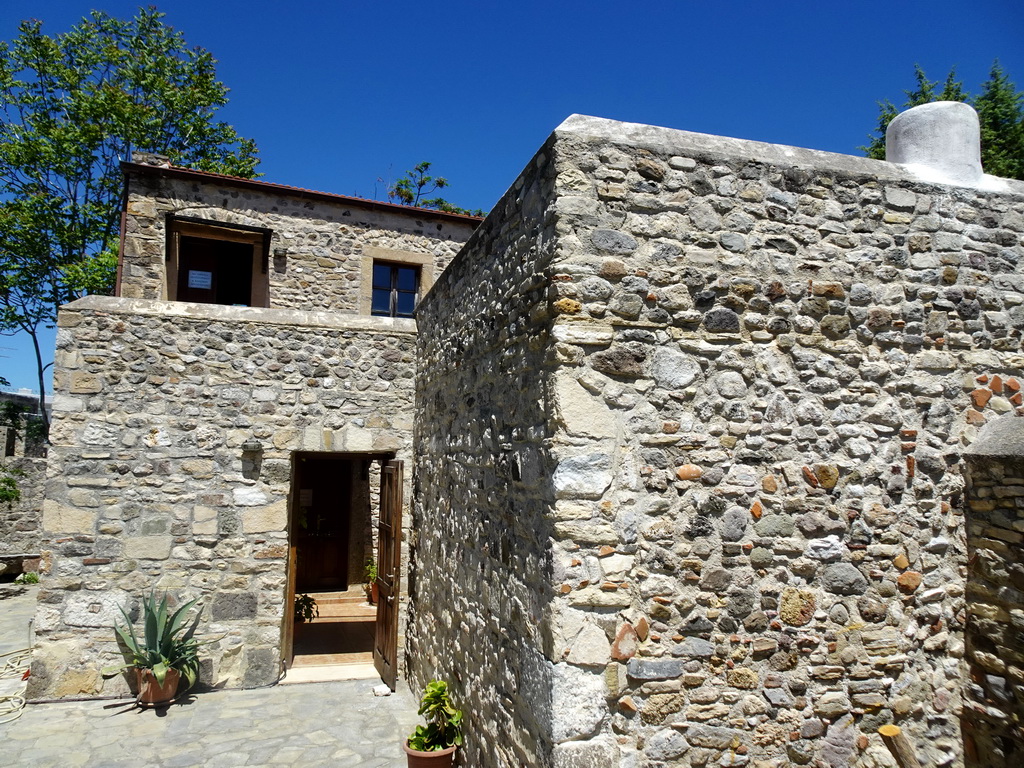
[411,117,1024,767]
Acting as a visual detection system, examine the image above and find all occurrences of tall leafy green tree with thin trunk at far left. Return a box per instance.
[0,7,259,436]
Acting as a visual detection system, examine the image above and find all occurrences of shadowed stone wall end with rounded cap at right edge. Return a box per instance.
[964,420,1024,768]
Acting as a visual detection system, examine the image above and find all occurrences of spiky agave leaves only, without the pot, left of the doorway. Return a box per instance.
[102,592,203,688]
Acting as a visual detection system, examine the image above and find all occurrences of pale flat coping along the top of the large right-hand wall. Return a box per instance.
[554,115,1024,196]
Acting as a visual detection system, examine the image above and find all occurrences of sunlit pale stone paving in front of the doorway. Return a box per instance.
[0,589,417,768]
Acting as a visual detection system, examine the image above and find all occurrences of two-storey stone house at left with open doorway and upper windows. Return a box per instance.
[29,157,479,698]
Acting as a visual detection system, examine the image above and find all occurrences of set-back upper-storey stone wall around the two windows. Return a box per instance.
[120,166,478,314]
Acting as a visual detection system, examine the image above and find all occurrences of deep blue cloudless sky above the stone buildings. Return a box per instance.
[0,0,1024,388]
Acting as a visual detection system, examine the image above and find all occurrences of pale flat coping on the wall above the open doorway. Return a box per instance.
[57,296,416,335]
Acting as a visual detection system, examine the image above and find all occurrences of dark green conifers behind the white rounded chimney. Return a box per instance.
[860,61,1024,179]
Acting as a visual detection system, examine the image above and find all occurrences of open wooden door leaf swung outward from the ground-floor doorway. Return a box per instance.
[374,460,402,690]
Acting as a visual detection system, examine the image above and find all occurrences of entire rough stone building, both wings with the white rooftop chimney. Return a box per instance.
[25,104,1024,768]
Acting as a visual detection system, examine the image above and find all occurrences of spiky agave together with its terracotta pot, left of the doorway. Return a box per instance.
[102,592,202,706]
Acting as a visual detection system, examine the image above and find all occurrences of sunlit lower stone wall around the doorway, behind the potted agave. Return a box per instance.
[29,297,415,698]
